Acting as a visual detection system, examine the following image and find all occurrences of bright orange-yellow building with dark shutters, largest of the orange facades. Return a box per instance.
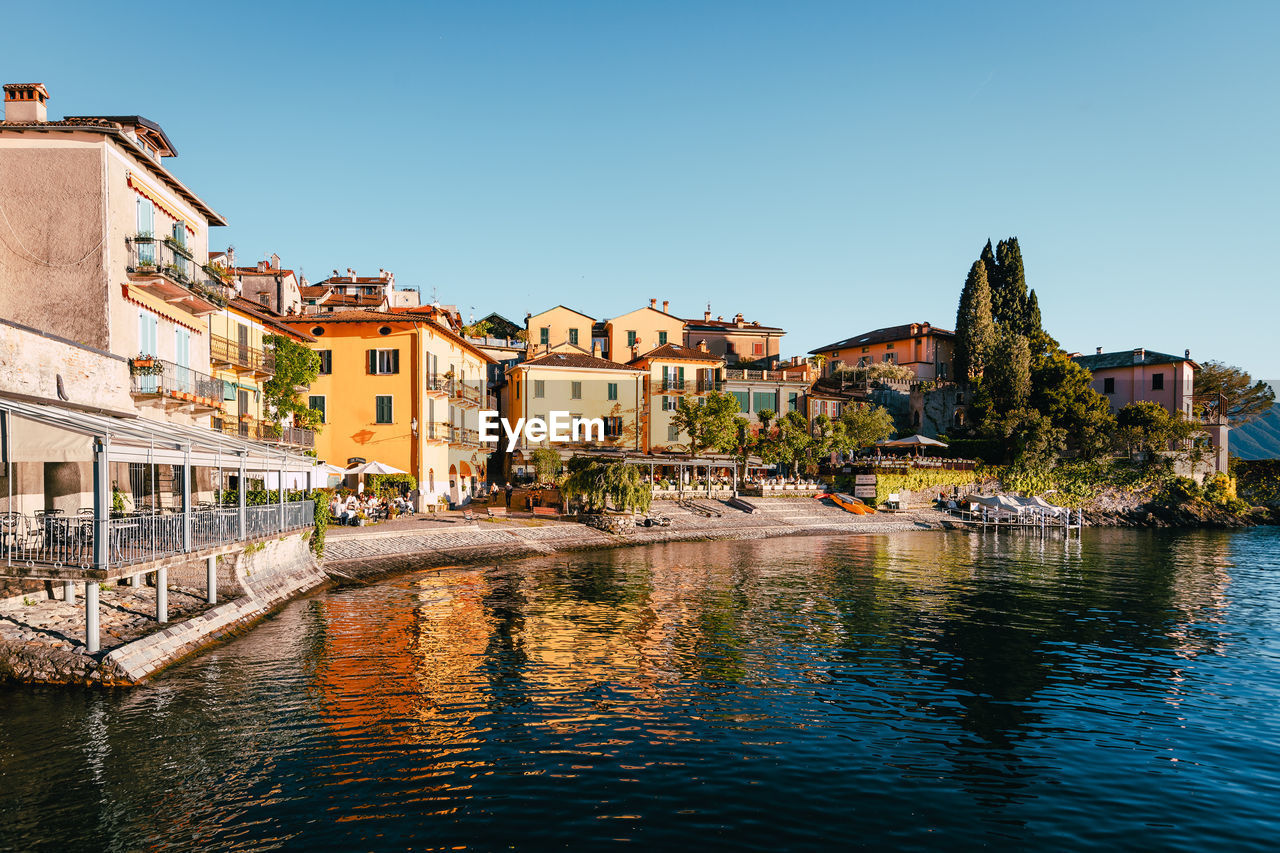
[285,311,490,505]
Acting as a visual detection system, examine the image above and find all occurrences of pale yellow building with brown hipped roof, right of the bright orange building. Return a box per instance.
[500,352,645,473]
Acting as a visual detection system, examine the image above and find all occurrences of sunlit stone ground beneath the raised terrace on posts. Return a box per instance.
[0,584,216,654]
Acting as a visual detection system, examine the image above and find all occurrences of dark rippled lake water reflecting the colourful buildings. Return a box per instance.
[0,529,1280,850]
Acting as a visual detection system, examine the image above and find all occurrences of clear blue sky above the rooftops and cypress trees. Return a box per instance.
[12,0,1280,378]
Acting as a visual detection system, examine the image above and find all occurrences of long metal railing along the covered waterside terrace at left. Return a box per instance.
[0,501,315,567]
